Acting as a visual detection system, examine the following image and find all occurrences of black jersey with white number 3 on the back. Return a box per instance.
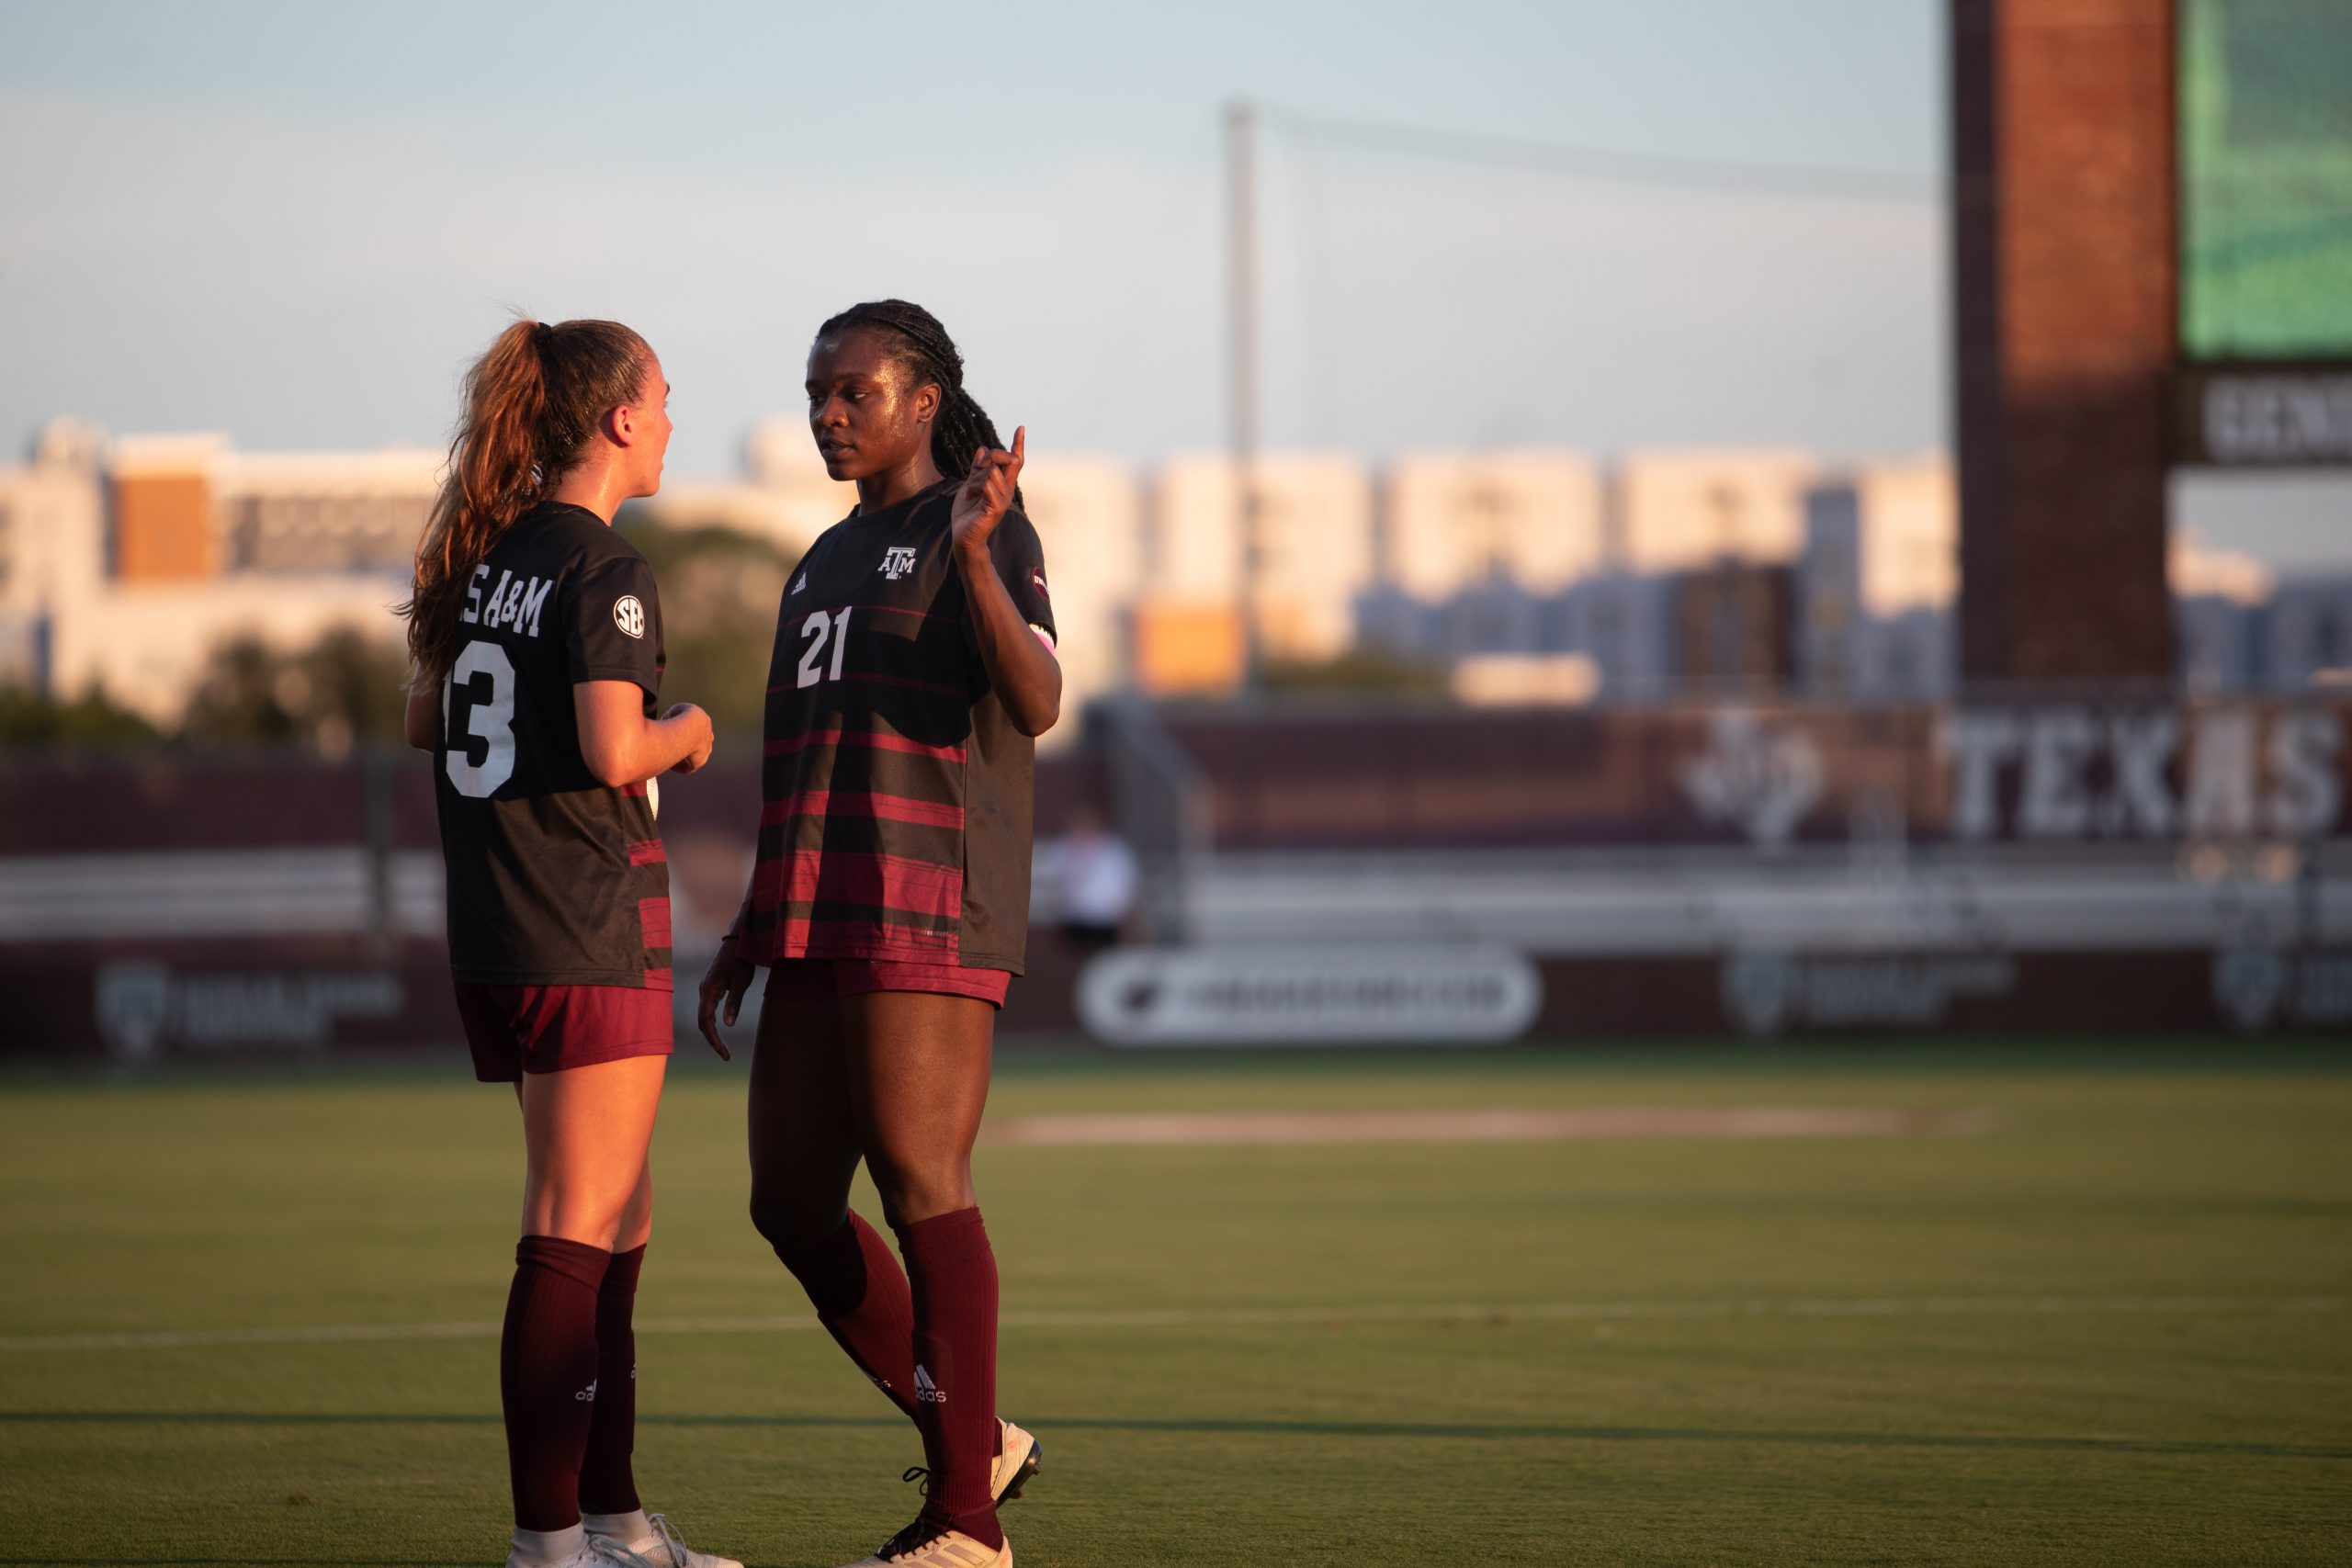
[433,503,671,989]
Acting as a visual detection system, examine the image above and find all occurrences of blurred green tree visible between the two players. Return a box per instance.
[618,510,793,733]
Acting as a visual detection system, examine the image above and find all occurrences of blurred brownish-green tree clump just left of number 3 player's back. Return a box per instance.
[181,626,409,760]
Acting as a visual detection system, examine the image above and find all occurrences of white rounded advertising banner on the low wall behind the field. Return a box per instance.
[1077,942,1543,1046]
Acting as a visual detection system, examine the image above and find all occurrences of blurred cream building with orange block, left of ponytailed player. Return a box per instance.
[0,421,418,724]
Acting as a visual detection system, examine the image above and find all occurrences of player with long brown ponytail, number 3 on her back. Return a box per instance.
[402,322,741,1568]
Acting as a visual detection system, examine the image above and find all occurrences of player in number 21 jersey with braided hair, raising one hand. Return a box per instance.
[701,301,1061,1568]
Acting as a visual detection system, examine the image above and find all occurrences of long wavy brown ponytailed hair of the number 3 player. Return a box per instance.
[400,320,651,684]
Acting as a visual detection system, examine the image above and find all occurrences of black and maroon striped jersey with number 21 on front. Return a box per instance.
[748,482,1054,974]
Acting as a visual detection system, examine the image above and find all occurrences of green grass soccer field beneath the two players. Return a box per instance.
[0,1043,2352,1568]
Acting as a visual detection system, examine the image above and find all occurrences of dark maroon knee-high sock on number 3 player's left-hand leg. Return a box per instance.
[499,1236,612,1530]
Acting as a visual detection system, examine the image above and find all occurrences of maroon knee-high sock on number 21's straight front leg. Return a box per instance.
[899,1208,1004,1547]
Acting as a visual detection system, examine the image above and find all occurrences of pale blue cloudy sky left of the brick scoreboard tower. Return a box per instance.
[0,0,1948,475]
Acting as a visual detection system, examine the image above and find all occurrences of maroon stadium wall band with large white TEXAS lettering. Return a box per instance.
[1169,698,2352,851]
